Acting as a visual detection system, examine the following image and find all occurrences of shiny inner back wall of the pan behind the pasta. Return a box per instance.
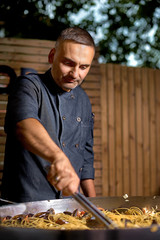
[0,196,160,217]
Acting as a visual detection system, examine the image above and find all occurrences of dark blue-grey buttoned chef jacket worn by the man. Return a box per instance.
[2,70,94,202]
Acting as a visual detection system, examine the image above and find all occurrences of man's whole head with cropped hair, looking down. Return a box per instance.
[49,27,95,91]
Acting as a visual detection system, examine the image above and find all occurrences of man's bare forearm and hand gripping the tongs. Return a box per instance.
[16,118,80,196]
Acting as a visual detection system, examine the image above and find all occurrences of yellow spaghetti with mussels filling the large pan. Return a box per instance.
[0,207,160,231]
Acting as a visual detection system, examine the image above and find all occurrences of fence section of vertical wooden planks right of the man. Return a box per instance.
[101,64,160,196]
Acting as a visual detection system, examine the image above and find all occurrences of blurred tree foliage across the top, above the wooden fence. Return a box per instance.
[0,0,160,68]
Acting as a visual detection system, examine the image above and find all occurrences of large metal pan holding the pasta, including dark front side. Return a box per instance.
[0,197,160,240]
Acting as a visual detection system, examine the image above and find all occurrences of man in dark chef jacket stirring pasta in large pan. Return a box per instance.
[2,28,96,202]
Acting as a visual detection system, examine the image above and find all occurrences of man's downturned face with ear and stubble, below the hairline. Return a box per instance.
[49,40,95,91]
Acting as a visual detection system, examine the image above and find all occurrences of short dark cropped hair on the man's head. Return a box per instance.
[55,27,95,49]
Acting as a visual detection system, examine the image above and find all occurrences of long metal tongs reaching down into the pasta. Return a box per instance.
[72,192,118,229]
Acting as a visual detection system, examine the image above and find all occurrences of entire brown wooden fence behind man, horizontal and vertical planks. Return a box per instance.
[0,38,160,196]
